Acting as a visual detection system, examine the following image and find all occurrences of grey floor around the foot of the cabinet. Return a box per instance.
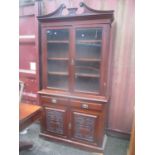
[20,124,129,155]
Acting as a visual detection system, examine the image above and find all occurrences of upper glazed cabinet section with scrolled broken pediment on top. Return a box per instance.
[38,3,113,99]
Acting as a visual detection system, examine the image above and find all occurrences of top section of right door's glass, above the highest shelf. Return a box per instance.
[76,28,102,40]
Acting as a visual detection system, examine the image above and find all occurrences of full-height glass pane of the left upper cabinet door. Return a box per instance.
[47,29,69,90]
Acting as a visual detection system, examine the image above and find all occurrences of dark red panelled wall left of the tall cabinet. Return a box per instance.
[19,1,39,104]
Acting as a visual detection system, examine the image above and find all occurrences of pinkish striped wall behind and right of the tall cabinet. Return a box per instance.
[43,0,135,133]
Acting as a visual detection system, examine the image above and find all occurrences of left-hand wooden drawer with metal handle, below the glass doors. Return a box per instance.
[40,96,69,106]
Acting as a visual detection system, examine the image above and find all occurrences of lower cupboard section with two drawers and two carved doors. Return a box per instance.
[40,95,106,152]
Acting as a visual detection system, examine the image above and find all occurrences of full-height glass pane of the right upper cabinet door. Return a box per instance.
[75,28,102,93]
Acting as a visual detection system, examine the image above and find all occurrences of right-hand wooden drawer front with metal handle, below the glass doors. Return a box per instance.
[71,100,103,111]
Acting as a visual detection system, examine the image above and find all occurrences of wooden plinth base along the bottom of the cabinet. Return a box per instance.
[40,133,107,155]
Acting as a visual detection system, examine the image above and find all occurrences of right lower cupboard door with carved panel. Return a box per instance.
[71,110,102,145]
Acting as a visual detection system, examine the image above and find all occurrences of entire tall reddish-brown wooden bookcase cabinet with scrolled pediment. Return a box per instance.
[38,3,113,151]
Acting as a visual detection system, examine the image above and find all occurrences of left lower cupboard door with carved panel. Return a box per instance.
[45,107,67,136]
